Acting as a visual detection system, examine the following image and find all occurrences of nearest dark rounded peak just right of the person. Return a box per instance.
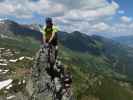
[59,31,103,54]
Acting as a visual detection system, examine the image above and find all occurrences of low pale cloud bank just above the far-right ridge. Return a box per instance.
[90,20,133,37]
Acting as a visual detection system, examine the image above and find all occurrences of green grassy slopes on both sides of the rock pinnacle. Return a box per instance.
[0,38,133,100]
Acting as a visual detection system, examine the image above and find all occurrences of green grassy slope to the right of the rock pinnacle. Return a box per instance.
[61,47,133,100]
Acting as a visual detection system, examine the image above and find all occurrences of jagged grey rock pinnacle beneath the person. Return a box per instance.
[27,47,74,100]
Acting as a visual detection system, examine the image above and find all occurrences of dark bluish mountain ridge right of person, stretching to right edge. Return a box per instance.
[59,32,133,79]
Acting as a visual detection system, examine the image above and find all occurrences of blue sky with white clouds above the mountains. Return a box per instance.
[0,0,133,37]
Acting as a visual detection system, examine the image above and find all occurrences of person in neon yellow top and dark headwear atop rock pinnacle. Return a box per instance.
[41,17,59,59]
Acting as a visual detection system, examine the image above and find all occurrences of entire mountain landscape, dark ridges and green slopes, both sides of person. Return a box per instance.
[0,20,133,100]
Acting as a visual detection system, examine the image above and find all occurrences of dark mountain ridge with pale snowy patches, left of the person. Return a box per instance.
[0,20,41,40]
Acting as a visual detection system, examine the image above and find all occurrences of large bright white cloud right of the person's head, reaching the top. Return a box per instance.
[53,0,119,33]
